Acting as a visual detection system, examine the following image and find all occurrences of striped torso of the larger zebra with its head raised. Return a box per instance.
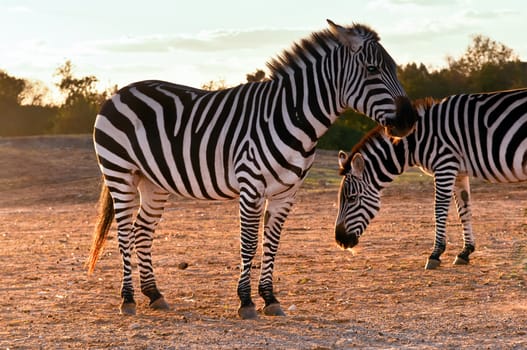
[94,81,326,200]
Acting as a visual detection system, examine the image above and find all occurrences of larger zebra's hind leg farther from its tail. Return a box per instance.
[134,178,169,310]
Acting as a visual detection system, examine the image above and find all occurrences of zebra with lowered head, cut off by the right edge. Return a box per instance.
[335,89,527,269]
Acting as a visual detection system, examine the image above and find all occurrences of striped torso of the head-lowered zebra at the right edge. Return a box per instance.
[414,89,527,182]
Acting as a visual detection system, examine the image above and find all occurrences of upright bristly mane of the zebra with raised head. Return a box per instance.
[267,24,381,79]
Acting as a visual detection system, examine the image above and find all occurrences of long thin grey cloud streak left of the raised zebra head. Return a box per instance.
[96,29,308,53]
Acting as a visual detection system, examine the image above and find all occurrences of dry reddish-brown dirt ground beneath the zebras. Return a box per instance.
[0,136,527,349]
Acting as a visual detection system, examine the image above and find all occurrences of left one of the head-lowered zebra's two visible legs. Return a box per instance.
[425,174,455,270]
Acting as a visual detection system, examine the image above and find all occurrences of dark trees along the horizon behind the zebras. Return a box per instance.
[0,35,527,150]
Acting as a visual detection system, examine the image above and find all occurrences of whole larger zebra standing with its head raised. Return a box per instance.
[87,20,416,319]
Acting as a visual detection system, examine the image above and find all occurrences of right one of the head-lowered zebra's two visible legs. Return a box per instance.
[454,176,476,265]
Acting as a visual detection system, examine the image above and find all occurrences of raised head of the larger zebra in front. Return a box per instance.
[327,20,417,137]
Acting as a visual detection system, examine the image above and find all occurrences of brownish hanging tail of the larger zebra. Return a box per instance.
[86,182,115,274]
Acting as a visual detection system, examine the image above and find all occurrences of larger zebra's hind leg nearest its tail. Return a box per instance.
[105,172,139,315]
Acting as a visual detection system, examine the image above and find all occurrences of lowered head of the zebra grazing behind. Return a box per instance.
[335,151,381,249]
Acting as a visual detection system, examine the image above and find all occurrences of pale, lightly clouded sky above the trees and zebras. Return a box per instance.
[0,0,527,98]
